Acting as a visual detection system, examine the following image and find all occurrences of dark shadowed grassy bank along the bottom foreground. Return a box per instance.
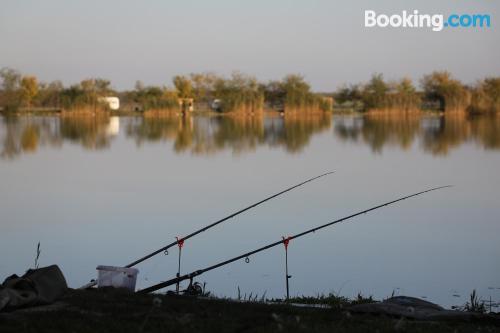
[0,288,500,333]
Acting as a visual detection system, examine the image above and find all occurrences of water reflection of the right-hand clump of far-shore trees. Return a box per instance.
[334,114,500,155]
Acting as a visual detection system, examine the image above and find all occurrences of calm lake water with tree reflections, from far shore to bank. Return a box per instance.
[0,114,500,306]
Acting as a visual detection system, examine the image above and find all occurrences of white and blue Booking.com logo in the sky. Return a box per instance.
[365,10,491,31]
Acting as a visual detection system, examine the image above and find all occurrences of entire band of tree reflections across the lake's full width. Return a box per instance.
[0,113,500,158]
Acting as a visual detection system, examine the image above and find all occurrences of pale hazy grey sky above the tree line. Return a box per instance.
[0,0,500,91]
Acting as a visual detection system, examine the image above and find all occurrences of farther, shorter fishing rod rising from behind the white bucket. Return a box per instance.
[80,171,335,289]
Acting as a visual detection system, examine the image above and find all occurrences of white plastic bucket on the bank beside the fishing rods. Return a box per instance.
[97,266,139,291]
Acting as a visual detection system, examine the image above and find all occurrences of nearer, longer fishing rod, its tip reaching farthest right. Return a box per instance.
[138,185,452,293]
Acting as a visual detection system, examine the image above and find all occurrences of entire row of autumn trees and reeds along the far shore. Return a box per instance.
[0,68,500,113]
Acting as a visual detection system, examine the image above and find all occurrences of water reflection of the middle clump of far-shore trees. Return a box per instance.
[127,113,331,154]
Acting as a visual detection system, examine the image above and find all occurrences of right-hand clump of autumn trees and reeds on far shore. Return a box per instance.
[334,71,500,113]
